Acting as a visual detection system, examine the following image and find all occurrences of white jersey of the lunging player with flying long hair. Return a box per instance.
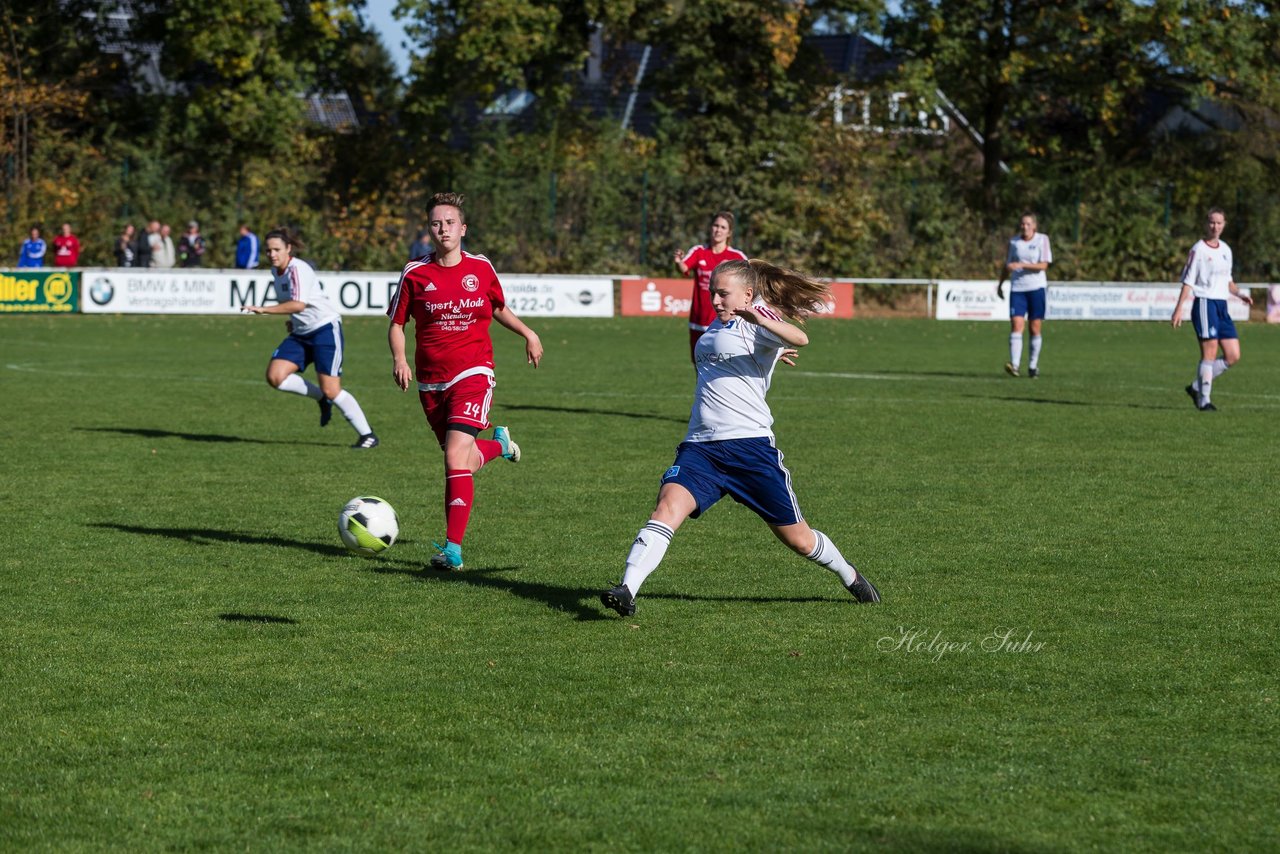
[685,302,786,442]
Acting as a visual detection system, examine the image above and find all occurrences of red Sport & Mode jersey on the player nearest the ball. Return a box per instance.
[387,252,507,384]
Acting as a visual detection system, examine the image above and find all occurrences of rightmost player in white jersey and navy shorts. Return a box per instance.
[1170,207,1253,412]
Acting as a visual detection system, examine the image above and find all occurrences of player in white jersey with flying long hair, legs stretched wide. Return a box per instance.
[600,260,879,617]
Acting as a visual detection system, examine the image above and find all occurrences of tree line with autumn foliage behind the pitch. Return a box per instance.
[0,0,1280,280]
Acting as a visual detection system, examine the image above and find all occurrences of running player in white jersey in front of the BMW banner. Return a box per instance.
[243,228,378,449]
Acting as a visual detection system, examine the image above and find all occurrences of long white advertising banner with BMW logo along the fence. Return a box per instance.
[82,268,613,318]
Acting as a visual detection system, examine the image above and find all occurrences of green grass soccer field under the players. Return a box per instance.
[0,316,1280,851]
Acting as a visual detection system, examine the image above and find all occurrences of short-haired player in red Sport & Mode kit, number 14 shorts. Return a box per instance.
[387,193,543,570]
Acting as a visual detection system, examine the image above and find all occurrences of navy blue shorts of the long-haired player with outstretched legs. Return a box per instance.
[662,437,804,525]
